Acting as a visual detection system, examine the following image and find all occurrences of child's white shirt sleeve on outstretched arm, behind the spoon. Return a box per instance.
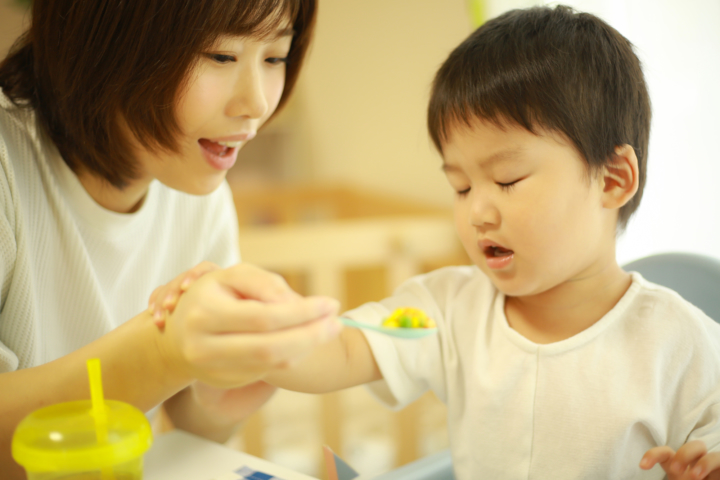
[345,275,446,409]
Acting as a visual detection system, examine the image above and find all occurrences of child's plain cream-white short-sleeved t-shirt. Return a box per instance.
[347,267,720,480]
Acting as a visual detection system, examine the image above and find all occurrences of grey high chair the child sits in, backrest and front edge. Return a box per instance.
[375,253,720,480]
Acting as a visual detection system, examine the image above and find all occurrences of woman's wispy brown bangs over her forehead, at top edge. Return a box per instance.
[214,0,300,39]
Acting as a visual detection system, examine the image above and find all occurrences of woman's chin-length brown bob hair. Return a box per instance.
[0,0,316,188]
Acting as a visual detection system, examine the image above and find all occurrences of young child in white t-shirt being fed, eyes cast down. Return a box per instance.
[155,7,720,480]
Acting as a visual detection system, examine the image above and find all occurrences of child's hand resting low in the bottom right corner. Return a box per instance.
[640,440,720,480]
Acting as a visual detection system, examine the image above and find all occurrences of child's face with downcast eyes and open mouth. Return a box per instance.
[443,121,617,296]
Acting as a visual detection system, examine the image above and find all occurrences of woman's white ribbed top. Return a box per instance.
[0,91,239,373]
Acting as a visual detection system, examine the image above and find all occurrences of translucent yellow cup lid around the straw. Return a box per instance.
[12,400,152,472]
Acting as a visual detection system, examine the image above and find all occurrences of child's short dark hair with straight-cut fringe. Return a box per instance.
[428,6,651,229]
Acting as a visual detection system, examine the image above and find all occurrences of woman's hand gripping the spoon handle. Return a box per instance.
[155,263,342,389]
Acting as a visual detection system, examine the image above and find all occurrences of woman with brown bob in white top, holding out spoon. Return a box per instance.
[0,0,339,479]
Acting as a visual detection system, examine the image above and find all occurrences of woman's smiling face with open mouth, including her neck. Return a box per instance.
[138,29,292,195]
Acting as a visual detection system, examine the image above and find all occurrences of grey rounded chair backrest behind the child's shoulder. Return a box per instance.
[623,253,720,322]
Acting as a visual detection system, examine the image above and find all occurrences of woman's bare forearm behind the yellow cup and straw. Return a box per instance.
[0,312,191,480]
